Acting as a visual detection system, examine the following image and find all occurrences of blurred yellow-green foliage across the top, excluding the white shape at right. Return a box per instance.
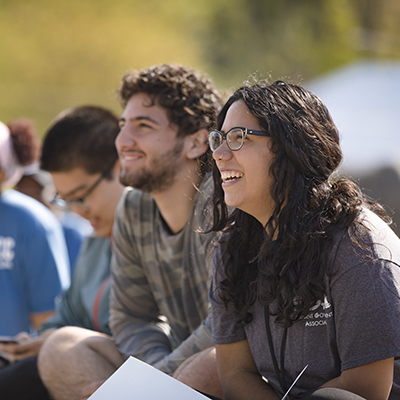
[0,0,400,134]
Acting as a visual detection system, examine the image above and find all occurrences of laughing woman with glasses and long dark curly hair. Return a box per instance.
[209,81,400,400]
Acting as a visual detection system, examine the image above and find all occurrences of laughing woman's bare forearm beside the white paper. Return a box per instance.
[215,340,280,400]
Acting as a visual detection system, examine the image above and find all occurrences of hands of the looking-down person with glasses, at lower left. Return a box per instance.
[0,329,54,362]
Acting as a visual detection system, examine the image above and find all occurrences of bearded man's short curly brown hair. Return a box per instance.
[118,64,222,175]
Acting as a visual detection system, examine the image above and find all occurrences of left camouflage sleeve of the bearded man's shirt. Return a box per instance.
[110,192,171,365]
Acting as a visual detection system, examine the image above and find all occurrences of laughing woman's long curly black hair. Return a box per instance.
[212,81,386,326]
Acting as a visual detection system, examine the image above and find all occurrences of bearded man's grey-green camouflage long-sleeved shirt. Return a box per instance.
[110,177,216,374]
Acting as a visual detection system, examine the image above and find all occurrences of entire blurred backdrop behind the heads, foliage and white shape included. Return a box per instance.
[0,0,400,231]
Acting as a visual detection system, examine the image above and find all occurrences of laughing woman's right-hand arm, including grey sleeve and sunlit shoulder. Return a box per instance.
[322,228,400,400]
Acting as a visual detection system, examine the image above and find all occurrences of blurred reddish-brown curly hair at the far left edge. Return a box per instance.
[7,118,41,166]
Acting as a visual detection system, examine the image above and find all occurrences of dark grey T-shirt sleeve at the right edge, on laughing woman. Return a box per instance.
[331,259,400,371]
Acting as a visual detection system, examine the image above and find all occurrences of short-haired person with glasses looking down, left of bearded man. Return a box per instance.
[0,106,124,400]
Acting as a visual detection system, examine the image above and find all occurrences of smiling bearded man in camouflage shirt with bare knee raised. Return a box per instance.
[39,64,225,400]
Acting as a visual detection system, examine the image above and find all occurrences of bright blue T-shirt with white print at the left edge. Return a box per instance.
[0,190,70,335]
